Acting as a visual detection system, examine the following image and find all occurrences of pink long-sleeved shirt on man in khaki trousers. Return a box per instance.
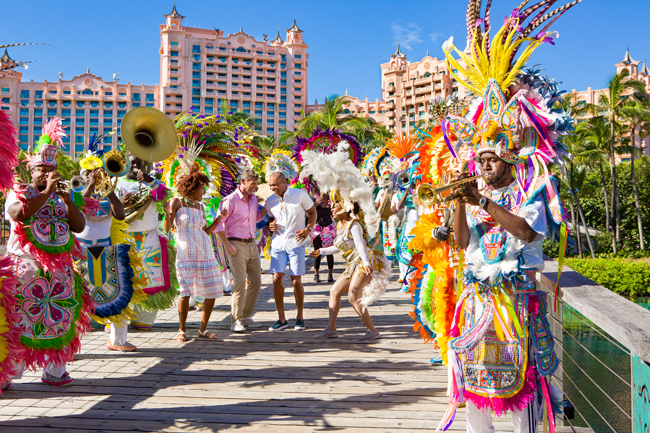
[217,187,262,239]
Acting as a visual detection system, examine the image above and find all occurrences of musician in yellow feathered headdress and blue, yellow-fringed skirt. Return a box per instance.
[76,136,147,352]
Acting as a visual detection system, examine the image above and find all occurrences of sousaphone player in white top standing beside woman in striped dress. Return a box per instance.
[116,154,173,330]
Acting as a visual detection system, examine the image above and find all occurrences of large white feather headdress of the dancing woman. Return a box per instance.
[300,141,381,239]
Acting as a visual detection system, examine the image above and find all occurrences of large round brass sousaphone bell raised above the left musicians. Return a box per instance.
[121,107,177,162]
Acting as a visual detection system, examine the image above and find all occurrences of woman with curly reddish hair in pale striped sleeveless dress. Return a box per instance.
[165,164,225,341]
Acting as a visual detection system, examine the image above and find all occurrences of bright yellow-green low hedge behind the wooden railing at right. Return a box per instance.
[565,258,650,298]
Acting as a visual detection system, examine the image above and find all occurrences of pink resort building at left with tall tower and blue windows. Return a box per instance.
[0,6,308,157]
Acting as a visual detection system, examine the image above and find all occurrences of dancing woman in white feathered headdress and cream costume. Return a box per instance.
[300,142,391,341]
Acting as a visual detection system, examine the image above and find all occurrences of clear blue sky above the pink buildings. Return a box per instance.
[5,0,650,103]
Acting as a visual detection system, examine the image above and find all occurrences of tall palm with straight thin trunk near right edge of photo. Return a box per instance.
[598,70,645,253]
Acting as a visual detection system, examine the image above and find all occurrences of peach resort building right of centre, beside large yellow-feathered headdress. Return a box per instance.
[307,45,465,133]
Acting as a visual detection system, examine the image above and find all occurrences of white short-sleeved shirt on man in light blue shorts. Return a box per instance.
[265,188,314,250]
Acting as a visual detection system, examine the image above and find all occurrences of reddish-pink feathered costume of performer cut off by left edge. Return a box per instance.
[0,103,23,395]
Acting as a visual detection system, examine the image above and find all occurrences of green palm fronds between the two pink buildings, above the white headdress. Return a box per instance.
[280,95,372,143]
